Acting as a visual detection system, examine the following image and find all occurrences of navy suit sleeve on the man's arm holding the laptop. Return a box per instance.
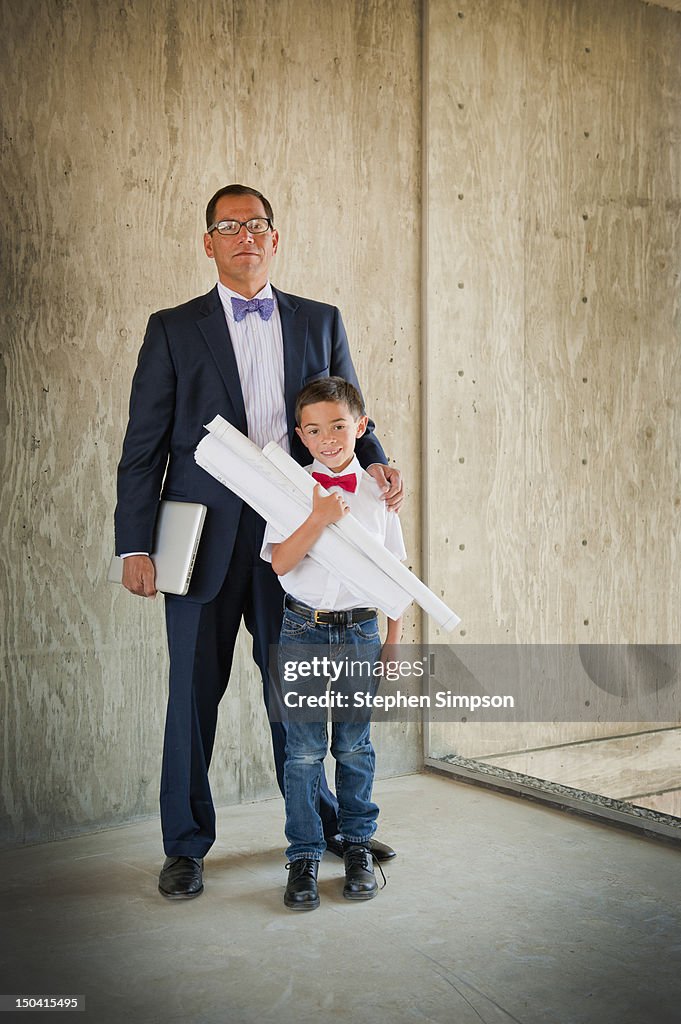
[114,313,176,554]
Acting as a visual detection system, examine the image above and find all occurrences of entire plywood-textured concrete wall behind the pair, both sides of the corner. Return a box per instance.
[0,0,681,842]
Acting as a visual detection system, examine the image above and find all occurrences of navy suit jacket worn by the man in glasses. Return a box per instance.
[115,287,387,603]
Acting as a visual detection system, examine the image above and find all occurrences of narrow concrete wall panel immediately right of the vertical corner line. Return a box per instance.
[424,0,527,643]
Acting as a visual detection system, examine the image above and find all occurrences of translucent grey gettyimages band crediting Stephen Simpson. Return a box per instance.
[269,642,681,725]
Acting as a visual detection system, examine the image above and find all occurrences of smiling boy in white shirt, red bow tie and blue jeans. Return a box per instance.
[262,377,406,910]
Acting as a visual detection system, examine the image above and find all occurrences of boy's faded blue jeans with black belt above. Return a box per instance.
[278,608,381,861]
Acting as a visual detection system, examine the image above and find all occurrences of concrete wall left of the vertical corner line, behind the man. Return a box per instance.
[0,0,421,842]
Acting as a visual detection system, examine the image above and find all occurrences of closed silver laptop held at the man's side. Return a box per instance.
[109,501,206,595]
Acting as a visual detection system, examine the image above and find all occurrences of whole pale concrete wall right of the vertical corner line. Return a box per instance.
[424,0,681,761]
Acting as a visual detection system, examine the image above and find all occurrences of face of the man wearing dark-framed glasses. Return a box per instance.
[204,196,279,299]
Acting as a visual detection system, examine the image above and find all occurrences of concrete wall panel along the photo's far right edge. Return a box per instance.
[524,2,681,643]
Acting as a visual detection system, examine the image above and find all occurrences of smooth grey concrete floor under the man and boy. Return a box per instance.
[0,774,681,1024]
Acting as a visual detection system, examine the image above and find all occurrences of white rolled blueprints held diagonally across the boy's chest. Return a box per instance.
[195,416,460,631]
